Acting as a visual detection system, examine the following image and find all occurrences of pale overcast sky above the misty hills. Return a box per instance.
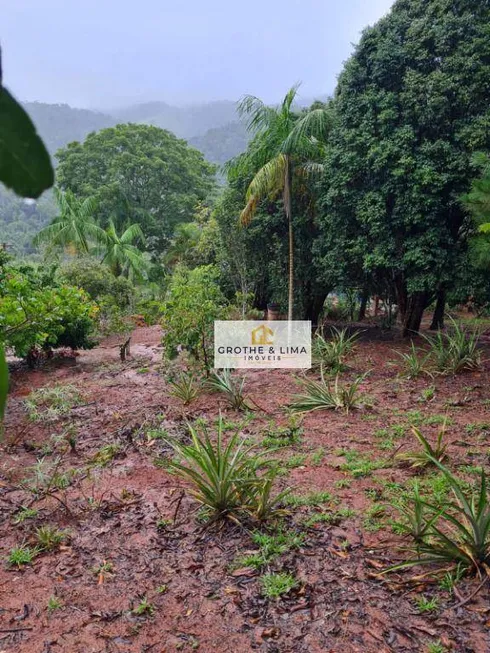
[0,0,393,108]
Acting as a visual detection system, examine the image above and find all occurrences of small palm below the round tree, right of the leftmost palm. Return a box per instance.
[101,220,149,278]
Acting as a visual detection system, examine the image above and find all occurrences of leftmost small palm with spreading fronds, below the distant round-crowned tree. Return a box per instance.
[34,188,104,254]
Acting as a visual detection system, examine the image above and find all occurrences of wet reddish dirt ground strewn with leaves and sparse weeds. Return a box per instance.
[0,327,490,653]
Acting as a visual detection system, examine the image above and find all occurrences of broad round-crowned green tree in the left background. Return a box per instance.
[57,124,215,252]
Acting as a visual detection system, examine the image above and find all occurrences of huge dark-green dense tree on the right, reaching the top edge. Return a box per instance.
[316,0,490,335]
